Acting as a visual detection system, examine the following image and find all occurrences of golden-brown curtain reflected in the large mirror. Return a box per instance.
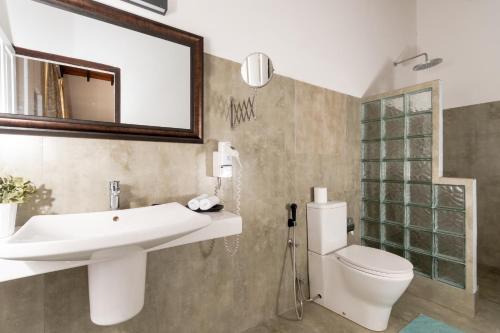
[42,63,70,119]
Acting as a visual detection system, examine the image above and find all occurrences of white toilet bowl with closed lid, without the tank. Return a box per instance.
[309,245,413,331]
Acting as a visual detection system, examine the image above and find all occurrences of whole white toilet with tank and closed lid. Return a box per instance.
[307,201,413,331]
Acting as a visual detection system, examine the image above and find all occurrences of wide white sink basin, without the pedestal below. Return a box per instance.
[0,202,211,261]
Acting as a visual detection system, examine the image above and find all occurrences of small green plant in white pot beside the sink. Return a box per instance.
[0,176,36,238]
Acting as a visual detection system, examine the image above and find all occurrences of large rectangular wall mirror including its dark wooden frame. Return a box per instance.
[0,0,203,143]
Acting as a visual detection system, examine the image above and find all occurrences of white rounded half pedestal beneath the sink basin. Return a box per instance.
[88,251,147,325]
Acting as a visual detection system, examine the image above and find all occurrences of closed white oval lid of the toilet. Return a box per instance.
[335,245,413,274]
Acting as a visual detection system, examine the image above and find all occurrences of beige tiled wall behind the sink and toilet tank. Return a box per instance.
[0,55,360,333]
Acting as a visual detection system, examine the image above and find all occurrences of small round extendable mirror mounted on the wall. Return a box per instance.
[241,52,274,88]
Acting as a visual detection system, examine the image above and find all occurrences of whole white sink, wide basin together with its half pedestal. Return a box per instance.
[0,203,212,325]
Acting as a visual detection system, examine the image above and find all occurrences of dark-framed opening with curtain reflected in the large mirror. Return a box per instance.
[12,56,120,122]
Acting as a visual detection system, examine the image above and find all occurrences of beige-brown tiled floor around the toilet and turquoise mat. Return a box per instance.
[245,267,500,333]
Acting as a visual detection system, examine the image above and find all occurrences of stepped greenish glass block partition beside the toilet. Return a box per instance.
[361,90,465,288]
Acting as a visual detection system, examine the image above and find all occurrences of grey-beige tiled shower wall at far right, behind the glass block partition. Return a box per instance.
[444,101,500,269]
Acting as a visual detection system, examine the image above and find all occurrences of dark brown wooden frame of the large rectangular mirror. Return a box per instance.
[0,0,203,143]
